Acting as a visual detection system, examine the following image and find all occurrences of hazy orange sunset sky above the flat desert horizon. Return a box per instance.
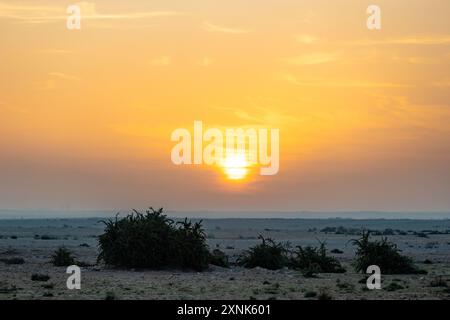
[0,0,450,215]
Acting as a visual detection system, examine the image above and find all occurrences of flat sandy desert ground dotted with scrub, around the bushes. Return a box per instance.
[0,219,450,299]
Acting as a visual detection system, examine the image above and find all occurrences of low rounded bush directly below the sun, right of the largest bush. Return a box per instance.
[237,235,289,270]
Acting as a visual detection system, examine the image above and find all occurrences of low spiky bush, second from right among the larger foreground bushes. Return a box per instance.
[291,242,345,276]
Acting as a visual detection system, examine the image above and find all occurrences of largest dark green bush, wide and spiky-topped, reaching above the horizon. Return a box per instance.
[98,208,210,271]
